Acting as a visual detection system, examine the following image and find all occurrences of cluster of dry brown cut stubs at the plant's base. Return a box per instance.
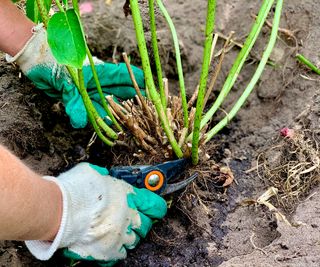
[106,96,206,161]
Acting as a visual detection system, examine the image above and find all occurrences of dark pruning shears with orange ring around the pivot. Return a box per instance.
[109,159,198,195]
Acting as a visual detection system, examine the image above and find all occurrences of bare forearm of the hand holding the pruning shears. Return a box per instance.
[0,145,62,240]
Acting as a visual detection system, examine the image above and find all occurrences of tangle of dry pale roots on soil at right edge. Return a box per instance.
[258,130,320,211]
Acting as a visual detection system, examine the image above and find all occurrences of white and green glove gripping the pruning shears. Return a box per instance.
[26,163,167,266]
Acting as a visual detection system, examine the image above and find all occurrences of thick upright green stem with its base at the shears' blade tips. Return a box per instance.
[191,0,216,165]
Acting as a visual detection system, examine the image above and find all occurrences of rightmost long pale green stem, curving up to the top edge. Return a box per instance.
[205,0,283,142]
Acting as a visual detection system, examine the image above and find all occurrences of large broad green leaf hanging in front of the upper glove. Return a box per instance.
[47,9,86,69]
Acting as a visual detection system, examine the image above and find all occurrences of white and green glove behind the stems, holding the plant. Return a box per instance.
[6,24,144,128]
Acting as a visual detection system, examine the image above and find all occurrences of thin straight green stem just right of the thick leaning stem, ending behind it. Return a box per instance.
[149,0,167,109]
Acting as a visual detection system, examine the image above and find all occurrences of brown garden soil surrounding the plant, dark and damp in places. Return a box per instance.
[0,0,320,266]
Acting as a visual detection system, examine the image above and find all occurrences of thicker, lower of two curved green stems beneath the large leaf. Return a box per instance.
[77,69,118,141]
